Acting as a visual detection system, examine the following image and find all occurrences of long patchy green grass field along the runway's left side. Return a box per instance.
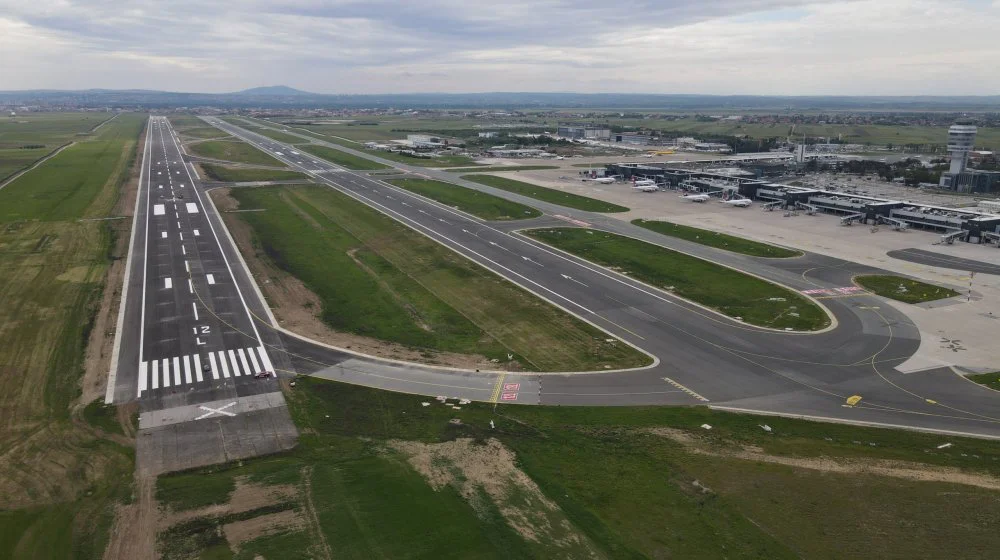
[0,114,146,558]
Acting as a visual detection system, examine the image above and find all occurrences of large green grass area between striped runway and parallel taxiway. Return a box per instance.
[219,187,649,371]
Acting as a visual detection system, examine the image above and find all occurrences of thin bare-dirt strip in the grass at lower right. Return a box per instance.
[648,428,1000,490]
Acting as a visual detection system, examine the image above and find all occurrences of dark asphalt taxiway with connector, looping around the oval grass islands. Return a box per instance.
[197,119,1000,436]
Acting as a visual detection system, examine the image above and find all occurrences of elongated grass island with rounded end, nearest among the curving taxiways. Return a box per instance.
[523,228,830,331]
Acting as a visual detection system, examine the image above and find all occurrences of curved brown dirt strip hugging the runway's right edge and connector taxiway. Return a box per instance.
[210,187,502,369]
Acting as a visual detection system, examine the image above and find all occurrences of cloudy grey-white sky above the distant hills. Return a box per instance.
[0,0,1000,95]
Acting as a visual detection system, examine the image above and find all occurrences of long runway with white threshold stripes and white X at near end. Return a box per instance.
[106,117,295,473]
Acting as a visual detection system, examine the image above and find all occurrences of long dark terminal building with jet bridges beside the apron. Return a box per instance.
[605,163,1000,243]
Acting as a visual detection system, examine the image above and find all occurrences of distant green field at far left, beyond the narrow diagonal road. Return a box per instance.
[0,113,113,182]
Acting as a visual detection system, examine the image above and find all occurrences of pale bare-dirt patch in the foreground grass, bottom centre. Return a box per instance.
[389,439,602,558]
